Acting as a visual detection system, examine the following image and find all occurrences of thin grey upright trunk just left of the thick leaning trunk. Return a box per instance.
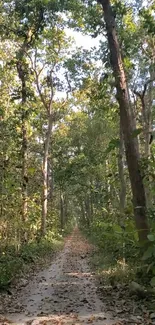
[118,119,126,214]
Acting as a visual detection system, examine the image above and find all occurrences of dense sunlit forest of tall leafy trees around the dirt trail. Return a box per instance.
[0,0,155,286]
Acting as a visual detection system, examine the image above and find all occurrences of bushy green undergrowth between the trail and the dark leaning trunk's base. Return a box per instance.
[84,221,141,285]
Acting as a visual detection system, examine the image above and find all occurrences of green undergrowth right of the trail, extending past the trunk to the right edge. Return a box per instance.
[84,220,155,287]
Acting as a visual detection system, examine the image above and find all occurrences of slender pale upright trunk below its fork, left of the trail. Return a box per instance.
[41,114,53,237]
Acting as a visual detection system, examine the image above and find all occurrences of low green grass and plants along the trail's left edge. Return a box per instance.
[0,238,64,292]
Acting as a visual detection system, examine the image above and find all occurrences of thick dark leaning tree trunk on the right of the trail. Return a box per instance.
[98,0,149,242]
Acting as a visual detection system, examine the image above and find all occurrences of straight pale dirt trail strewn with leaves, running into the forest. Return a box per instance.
[1,230,114,325]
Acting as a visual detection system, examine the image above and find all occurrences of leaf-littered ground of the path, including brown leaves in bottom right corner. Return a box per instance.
[0,229,155,325]
